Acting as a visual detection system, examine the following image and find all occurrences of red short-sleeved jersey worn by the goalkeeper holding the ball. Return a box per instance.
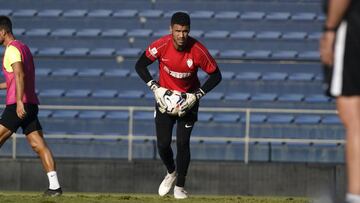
[146,34,217,92]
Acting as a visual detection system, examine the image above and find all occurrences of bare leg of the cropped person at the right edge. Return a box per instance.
[337,96,360,195]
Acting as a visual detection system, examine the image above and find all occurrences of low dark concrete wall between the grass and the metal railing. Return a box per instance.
[0,159,345,202]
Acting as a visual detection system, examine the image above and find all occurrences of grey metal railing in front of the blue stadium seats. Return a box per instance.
[7,105,345,163]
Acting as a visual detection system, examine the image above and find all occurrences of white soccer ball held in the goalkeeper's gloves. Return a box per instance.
[164,90,185,115]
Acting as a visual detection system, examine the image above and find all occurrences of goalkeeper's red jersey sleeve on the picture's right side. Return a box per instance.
[195,43,217,74]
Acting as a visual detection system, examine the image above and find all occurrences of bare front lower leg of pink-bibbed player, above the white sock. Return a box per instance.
[26,131,55,172]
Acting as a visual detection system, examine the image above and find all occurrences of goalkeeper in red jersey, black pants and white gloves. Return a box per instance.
[135,12,221,199]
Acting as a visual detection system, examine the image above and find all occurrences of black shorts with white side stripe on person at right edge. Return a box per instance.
[324,21,360,97]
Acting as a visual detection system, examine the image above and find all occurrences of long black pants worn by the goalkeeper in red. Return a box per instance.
[155,105,198,187]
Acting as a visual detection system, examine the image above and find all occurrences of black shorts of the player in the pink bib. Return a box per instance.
[0,104,42,135]
